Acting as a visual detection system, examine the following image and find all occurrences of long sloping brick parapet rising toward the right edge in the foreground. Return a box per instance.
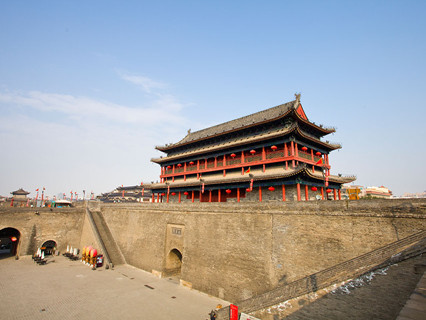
[218,231,426,319]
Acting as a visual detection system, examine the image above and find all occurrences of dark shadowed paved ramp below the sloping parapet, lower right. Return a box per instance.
[255,255,426,320]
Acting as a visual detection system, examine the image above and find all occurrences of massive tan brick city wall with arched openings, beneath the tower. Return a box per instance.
[0,199,426,301]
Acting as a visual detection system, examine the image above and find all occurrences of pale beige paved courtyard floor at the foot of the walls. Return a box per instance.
[0,256,229,320]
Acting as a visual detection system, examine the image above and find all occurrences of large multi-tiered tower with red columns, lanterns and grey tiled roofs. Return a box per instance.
[149,95,355,202]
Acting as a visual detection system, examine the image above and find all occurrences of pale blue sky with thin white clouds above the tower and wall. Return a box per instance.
[0,0,426,197]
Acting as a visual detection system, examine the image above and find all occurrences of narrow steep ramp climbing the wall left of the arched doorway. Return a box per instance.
[86,208,126,266]
